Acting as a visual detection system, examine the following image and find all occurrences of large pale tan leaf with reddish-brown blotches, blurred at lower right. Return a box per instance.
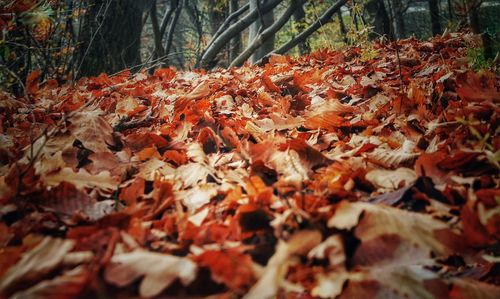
[328,201,458,266]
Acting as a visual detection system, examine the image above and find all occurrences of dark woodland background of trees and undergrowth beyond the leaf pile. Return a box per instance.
[0,0,500,94]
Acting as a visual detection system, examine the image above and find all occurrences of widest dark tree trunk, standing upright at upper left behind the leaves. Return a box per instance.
[75,0,144,78]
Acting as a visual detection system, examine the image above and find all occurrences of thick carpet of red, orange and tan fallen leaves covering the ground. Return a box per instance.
[0,34,500,298]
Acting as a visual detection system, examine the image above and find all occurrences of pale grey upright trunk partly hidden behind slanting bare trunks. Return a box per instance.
[248,0,274,63]
